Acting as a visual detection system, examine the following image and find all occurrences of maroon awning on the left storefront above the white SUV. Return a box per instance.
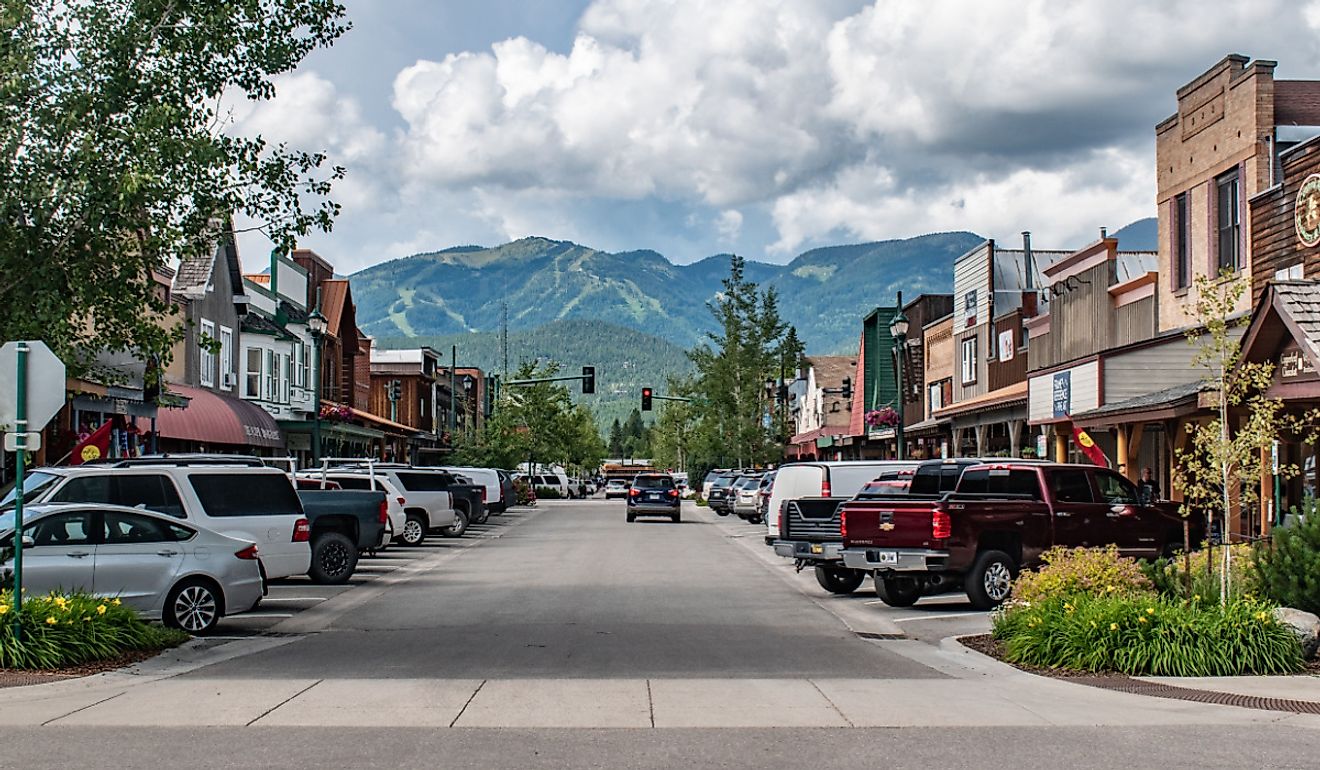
[156,386,284,448]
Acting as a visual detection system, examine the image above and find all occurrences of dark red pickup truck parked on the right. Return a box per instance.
[840,461,1204,609]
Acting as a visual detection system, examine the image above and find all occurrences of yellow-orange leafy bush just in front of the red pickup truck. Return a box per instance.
[1012,545,1152,604]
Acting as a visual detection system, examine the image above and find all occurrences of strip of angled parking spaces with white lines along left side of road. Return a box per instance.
[211,507,531,641]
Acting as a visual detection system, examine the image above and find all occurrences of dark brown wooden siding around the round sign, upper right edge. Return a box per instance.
[1250,137,1320,297]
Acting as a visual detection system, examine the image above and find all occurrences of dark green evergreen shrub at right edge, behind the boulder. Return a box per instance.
[1253,498,1320,614]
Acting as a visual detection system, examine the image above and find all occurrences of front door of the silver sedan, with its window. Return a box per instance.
[11,510,100,594]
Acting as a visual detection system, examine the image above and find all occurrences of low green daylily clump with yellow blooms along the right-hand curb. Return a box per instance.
[994,594,1303,676]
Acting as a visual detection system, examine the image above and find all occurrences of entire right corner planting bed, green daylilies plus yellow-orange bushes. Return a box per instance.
[973,547,1305,676]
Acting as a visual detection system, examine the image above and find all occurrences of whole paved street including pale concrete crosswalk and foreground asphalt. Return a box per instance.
[0,501,1320,767]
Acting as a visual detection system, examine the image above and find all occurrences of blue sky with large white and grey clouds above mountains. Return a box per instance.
[232,0,1320,273]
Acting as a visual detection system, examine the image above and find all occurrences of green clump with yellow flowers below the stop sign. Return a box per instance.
[0,590,189,668]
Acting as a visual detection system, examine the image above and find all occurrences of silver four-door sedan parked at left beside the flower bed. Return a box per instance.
[0,503,265,634]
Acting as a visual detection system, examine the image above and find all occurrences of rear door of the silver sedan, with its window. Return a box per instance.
[92,510,194,612]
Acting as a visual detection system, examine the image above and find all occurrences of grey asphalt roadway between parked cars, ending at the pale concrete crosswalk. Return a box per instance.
[190,499,942,679]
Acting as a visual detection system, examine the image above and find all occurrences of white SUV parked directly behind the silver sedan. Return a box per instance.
[0,457,312,578]
